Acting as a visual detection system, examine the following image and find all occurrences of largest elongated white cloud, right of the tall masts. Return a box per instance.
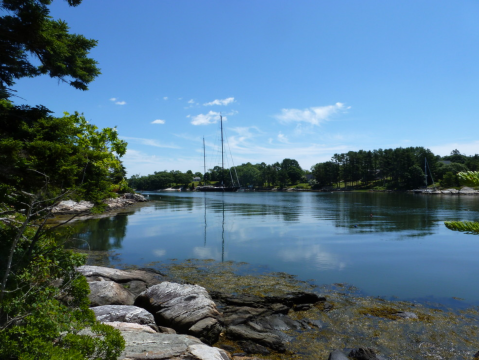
[274,102,351,125]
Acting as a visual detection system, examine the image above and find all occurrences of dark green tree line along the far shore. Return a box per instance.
[128,147,479,190]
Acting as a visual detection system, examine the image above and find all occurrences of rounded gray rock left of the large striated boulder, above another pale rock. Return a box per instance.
[88,281,135,307]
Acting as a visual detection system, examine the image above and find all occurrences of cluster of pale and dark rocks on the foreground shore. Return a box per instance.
[78,266,424,360]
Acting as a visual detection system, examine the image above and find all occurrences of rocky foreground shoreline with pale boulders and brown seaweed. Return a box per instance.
[78,266,479,360]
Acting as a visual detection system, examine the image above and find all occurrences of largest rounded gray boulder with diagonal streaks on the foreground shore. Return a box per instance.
[135,282,221,344]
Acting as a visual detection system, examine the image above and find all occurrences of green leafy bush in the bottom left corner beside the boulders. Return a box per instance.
[0,219,124,359]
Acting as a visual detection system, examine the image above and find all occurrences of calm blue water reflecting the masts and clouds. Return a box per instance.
[71,192,479,304]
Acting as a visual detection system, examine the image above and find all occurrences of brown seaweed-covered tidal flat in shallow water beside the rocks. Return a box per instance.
[79,253,479,360]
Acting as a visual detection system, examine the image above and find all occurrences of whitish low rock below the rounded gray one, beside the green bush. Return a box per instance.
[92,305,156,326]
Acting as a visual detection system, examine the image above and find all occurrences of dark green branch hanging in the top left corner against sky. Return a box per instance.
[0,0,100,99]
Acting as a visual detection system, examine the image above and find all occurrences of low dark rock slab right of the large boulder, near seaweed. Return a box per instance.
[226,323,286,352]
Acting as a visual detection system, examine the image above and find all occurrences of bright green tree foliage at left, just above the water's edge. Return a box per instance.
[0,100,127,210]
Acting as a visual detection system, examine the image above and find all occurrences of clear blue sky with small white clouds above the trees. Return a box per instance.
[11,0,479,176]
